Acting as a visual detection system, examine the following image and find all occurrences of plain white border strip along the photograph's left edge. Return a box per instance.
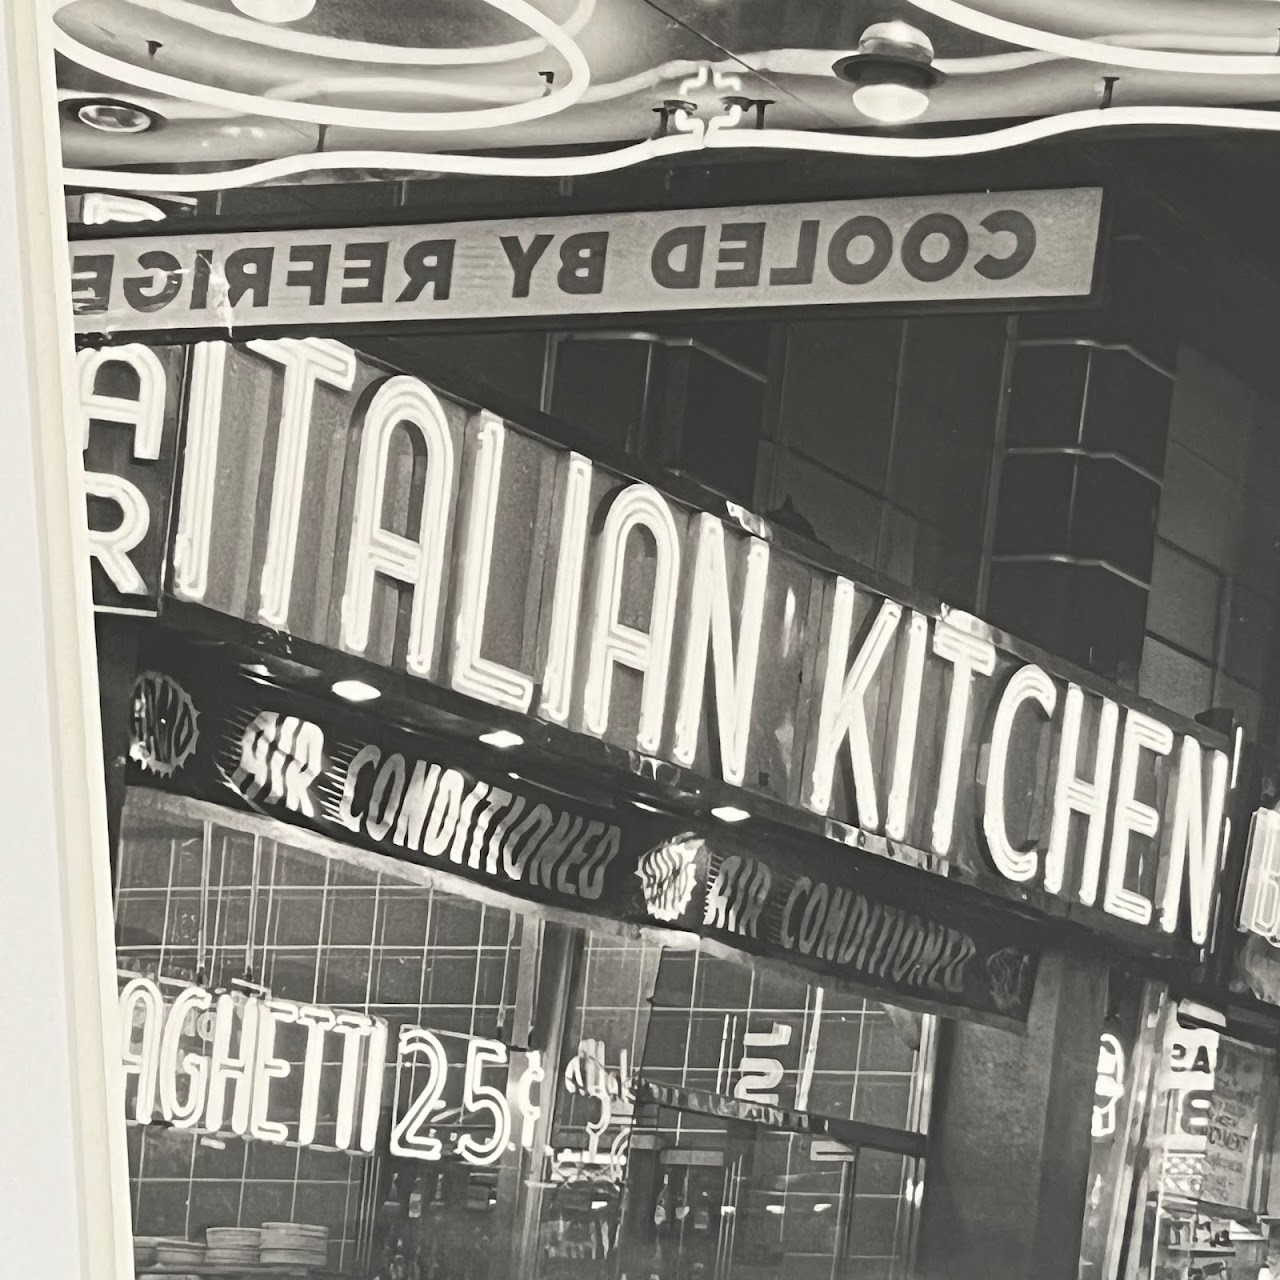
[0,0,133,1280]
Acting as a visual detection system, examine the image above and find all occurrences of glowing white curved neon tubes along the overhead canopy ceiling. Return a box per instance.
[55,0,1280,193]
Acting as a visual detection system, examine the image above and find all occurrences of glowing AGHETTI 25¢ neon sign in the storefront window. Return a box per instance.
[119,977,650,1179]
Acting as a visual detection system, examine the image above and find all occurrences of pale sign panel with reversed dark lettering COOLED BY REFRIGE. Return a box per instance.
[72,188,1102,334]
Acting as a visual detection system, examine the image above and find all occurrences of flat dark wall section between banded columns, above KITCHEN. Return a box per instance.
[756,315,1006,608]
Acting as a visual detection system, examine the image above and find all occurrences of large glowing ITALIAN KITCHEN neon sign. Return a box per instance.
[81,338,1230,946]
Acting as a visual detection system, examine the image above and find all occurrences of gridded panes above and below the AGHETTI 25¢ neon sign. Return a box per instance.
[116,803,520,1274]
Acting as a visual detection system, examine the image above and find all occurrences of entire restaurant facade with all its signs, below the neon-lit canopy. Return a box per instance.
[72,127,1280,1280]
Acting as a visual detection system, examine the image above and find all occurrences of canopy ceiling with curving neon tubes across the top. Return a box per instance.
[54,0,1280,191]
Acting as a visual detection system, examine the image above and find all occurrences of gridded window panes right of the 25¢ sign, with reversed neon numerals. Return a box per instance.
[636,950,927,1280]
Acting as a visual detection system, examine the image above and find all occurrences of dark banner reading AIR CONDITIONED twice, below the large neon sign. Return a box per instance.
[131,663,1036,1023]
